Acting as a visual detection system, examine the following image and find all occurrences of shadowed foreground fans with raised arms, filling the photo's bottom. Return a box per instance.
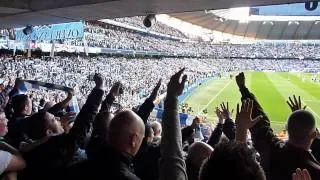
[0,61,320,180]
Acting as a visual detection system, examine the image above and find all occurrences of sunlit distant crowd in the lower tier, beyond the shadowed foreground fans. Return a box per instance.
[0,56,320,111]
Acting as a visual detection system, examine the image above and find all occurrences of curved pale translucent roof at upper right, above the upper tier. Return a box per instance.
[171,4,320,40]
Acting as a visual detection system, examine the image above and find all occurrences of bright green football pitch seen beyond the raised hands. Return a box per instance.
[184,72,320,132]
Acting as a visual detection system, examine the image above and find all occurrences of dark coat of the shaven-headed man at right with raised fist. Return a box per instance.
[240,88,320,180]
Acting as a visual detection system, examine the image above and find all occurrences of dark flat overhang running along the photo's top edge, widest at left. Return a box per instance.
[0,0,311,30]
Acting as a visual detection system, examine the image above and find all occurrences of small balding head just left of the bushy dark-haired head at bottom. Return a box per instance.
[186,141,213,180]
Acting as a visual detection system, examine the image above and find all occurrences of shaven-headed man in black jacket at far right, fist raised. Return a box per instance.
[236,73,320,180]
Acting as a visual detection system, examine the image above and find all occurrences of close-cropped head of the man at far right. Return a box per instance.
[287,110,318,149]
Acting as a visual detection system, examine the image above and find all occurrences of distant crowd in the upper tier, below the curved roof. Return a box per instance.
[63,23,320,59]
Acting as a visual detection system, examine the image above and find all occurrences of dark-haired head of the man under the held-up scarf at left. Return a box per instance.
[11,94,32,115]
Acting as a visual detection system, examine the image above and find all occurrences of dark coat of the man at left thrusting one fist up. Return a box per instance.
[22,89,104,179]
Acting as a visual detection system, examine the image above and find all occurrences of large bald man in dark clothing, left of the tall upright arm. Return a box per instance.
[65,110,145,180]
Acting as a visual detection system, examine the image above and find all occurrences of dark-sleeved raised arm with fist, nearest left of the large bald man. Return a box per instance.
[69,74,104,143]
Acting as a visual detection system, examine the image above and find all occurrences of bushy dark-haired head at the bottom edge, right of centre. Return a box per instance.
[199,142,266,180]
